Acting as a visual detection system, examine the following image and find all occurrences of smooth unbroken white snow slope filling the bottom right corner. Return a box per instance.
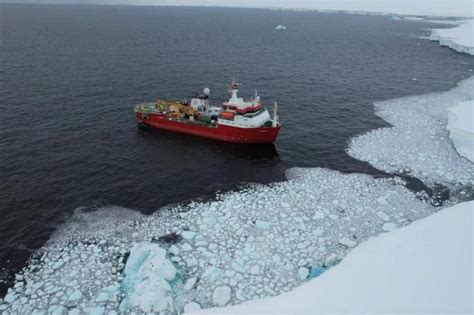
[198,201,474,314]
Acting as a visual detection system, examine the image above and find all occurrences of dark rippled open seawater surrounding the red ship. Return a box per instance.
[0,5,474,291]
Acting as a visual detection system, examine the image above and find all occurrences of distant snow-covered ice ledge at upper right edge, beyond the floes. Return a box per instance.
[430,19,474,55]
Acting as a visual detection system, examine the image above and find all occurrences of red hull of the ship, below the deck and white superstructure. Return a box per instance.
[135,112,281,143]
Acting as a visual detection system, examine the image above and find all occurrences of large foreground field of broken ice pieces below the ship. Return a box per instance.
[0,169,437,314]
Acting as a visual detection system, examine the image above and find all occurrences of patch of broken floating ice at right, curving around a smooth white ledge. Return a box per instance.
[348,77,474,187]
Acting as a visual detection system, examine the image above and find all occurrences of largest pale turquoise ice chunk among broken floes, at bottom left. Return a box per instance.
[120,242,176,313]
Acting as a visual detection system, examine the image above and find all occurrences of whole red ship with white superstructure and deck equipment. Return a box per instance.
[135,81,281,143]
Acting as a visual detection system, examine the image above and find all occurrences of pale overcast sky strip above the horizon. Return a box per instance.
[0,0,474,17]
